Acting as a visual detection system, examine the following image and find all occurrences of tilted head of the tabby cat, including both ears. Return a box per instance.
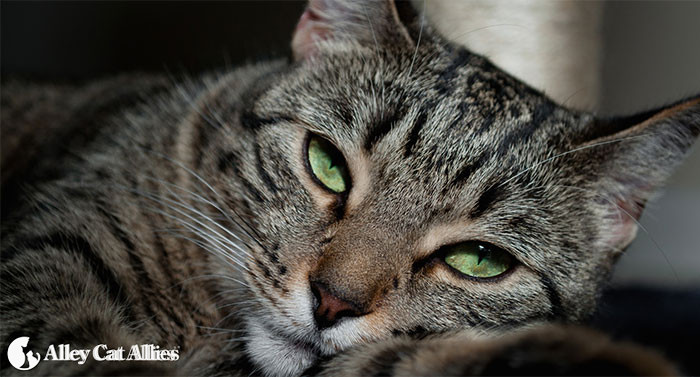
[198,1,697,374]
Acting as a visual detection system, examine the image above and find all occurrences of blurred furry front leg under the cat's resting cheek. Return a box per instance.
[308,325,678,376]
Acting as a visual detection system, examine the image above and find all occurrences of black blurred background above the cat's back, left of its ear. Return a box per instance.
[0,1,305,81]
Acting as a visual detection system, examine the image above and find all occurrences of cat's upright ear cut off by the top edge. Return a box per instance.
[292,0,416,61]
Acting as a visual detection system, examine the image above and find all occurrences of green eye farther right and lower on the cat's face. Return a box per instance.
[445,242,513,278]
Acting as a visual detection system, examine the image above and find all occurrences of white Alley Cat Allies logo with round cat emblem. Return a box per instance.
[7,336,180,370]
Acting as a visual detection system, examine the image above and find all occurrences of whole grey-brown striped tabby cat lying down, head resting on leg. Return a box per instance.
[0,0,700,376]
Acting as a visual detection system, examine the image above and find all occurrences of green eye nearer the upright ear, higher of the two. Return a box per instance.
[308,135,350,194]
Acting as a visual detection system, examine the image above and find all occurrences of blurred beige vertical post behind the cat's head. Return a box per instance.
[414,0,603,110]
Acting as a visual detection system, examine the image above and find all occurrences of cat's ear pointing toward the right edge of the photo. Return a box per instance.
[578,96,700,251]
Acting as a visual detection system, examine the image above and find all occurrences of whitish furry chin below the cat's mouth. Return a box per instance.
[246,321,318,376]
